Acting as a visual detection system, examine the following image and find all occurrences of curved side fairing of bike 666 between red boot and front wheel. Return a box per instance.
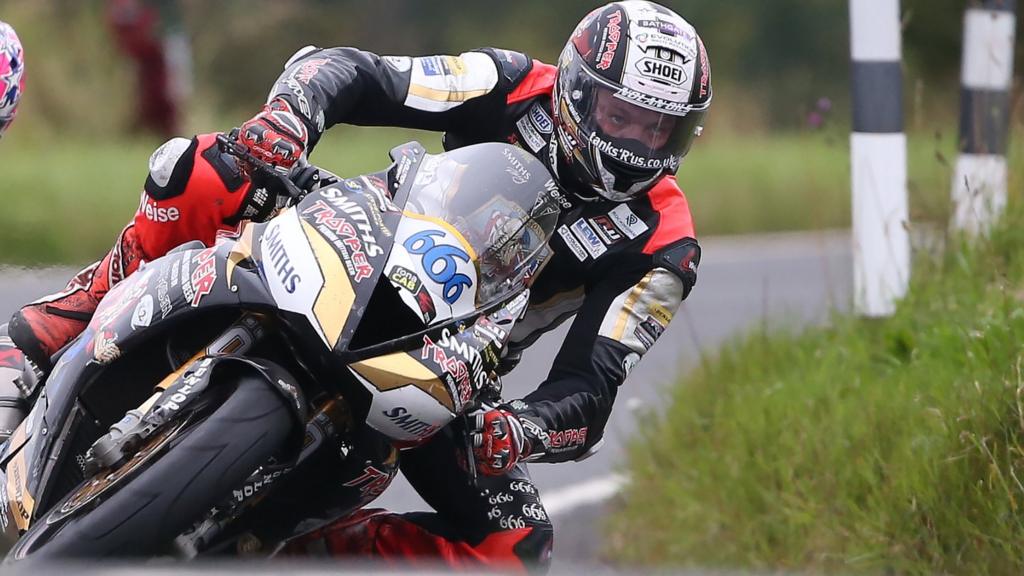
[0,239,273,538]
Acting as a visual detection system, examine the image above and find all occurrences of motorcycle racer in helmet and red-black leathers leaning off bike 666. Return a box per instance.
[10,0,712,569]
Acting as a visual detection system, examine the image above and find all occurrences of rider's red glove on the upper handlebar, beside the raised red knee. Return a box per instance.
[239,98,309,170]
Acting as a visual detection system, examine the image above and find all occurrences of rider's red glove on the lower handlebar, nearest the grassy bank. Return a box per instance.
[470,406,529,476]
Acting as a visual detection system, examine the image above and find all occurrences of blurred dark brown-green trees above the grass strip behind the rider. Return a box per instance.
[0,0,1024,134]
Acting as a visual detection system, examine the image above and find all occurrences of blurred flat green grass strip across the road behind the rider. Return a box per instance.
[0,126,1024,264]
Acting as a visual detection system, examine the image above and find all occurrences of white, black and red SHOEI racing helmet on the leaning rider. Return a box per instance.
[553,0,712,202]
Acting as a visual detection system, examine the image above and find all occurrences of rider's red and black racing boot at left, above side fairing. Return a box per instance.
[8,224,145,371]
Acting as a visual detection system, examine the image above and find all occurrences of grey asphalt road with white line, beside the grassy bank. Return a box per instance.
[0,232,852,568]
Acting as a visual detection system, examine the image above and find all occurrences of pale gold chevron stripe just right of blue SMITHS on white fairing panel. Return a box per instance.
[299,220,355,348]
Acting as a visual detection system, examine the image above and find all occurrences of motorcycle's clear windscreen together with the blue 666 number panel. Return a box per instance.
[397,143,558,315]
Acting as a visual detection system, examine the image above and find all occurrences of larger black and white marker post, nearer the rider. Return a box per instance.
[850,0,910,317]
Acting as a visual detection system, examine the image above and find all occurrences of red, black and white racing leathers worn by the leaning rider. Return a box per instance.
[8,44,699,569]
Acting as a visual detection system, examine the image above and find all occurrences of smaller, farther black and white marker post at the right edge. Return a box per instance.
[952,0,1017,234]
